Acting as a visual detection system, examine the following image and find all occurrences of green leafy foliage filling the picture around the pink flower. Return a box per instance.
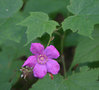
[0,0,99,90]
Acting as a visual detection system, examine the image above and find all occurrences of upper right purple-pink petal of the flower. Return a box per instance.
[44,45,60,59]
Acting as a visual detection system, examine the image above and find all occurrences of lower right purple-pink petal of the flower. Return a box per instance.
[47,59,60,74]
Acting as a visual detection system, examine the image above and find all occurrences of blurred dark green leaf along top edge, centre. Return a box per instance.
[24,0,69,14]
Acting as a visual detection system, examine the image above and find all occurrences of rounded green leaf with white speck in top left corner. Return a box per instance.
[0,0,23,18]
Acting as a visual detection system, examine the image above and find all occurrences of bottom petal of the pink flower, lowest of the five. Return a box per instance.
[33,64,47,78]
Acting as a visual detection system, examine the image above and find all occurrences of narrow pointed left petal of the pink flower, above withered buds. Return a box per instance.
[22,56,37,67]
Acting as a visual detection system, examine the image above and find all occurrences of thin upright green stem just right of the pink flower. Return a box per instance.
[61,33,66,78]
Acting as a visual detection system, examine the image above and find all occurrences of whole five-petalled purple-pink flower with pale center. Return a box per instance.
[22,43,60,78]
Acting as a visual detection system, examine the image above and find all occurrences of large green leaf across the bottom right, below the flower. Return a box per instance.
[30,67,99,90]
